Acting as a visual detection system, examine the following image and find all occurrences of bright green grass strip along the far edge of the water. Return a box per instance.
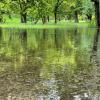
[0,18,95,29]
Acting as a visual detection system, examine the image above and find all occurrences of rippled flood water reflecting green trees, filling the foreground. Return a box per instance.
[0,28,100,100]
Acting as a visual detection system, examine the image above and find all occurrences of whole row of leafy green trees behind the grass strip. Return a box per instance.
[0,0,100,26]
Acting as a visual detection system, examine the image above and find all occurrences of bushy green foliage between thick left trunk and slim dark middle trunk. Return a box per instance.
[28,0,52,24]
